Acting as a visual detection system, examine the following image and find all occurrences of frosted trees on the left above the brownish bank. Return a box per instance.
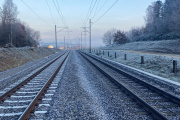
[0,0,40,47]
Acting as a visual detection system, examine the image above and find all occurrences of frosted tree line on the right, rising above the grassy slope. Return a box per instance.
[103,0,180,45]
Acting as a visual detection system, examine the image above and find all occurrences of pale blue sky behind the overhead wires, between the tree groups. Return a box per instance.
[0,0,165,46]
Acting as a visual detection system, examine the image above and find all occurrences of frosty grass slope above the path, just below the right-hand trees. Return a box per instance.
[101,40,180,53]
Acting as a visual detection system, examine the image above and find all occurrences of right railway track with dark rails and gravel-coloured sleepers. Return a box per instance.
[79,52,180,120]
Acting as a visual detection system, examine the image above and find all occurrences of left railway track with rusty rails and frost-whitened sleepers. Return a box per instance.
[0,52,69,120]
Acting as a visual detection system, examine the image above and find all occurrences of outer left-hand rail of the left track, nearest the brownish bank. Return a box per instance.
[0,52,66,102]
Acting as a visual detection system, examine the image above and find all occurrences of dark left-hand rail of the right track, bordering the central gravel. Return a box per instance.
[80,52,168,120]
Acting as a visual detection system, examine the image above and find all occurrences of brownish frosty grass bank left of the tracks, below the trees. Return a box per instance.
[0,47,60,72]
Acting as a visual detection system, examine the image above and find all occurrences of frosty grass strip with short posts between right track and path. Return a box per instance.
[90,50,180,82]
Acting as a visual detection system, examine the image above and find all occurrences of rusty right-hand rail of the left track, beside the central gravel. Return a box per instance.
[18,53,69,120]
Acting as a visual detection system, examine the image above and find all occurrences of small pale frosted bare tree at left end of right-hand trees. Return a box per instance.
[102,28,116,45]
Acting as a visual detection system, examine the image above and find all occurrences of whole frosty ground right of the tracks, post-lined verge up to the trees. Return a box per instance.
[89,40,180,82]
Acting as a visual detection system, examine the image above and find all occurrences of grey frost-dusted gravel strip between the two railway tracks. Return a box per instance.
[45,51,153,120]
